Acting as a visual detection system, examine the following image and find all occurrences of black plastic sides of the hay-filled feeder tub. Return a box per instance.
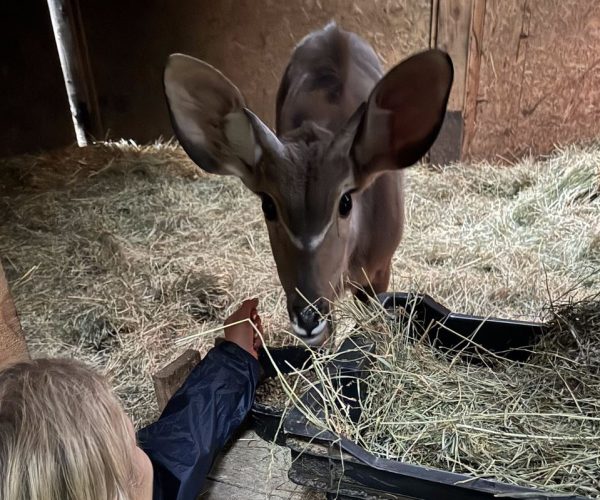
[251,293,585,500]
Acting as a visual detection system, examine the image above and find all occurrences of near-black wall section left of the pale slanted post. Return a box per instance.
[0,0,75,157]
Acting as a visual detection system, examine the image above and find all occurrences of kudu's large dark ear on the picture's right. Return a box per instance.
[352,50,454,182]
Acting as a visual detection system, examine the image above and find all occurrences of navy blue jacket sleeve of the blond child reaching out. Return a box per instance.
[137,341,259,500]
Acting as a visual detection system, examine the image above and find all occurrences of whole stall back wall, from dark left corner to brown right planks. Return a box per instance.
[0,0,600,162]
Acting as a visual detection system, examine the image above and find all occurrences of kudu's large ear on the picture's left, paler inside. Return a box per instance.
[164,54,281,189]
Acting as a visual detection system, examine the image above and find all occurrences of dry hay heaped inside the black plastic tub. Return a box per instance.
[268,294,600,498]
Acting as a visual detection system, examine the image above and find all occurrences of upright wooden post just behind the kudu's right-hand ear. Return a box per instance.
[429,0,485,165]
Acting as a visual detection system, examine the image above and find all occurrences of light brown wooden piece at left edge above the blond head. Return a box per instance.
[0,263,29,366]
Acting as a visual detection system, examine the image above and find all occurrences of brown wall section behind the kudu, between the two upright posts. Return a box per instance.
[80,0,431,142]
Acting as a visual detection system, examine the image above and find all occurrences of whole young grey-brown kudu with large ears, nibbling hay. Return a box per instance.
[164,24,453,345]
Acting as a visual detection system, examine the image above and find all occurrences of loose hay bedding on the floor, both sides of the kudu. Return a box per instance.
[0,138,600,438]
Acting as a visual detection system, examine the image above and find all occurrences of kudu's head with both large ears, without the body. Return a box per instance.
[164,50,453,345]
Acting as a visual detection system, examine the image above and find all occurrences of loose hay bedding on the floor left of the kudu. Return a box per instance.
[0,142,284,426]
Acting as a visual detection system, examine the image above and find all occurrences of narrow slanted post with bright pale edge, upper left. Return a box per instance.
[48,0,102,147]
